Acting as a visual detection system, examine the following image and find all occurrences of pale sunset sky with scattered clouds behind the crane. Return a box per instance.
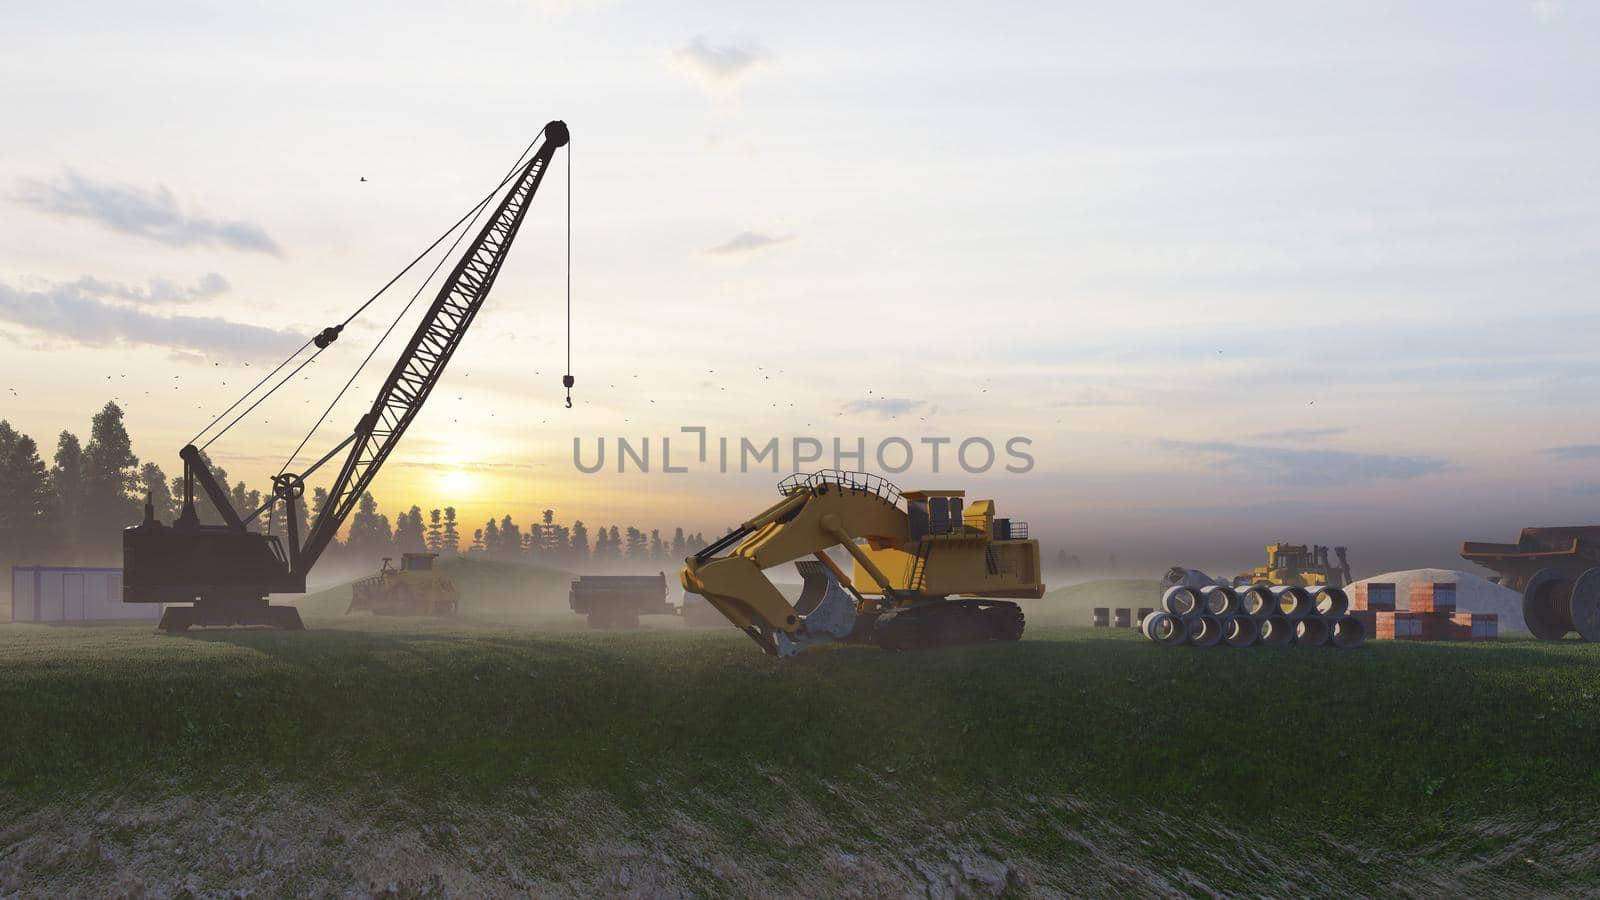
[0,0,1600,573]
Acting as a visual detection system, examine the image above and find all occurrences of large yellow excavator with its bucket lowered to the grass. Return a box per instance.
[680,469,1045,657]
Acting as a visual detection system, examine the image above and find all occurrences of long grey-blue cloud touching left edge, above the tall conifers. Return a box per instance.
[0,275,304,360]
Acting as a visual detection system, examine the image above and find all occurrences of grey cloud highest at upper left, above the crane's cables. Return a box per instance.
[16,168,283,256]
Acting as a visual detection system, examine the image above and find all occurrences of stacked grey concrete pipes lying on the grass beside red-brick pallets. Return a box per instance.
[1139,585,1366,650]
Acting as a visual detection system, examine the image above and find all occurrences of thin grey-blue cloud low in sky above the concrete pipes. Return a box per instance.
[1163,440,1451,487]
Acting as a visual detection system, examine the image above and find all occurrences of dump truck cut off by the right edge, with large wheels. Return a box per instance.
[1461,525,1600,641]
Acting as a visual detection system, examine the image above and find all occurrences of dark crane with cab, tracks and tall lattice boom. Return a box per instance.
[123,122,571,631]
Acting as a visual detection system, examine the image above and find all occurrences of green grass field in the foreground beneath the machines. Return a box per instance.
[0,573,1600,895]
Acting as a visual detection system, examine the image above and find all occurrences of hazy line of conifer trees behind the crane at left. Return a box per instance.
[0,402,707,567]
